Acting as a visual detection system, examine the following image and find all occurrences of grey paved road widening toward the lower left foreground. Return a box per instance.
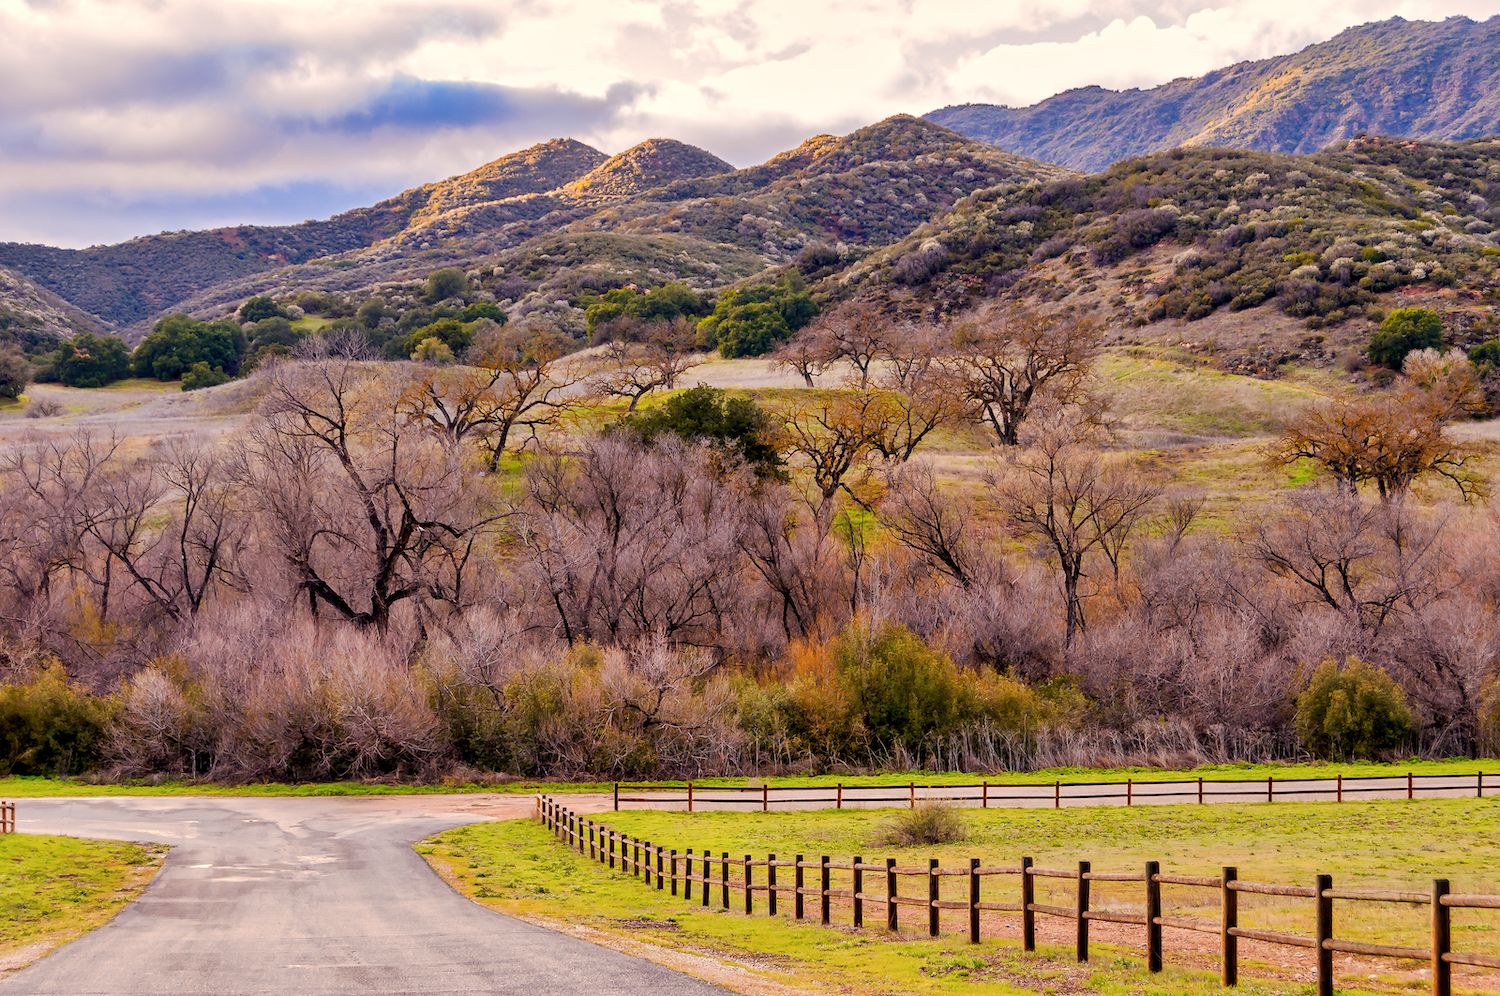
[0,795,723,996]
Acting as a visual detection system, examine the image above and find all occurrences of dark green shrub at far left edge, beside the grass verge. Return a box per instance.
[0,660,113,776]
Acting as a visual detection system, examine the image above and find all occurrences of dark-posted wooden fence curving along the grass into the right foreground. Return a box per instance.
[537,795,1500,996]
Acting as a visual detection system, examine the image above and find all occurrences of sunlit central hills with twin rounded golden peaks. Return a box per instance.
[138,116,1068,332]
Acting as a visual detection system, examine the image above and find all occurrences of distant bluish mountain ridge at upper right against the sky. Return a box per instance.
[927,17,1500,171]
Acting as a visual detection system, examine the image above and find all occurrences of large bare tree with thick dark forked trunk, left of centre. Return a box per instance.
[243,359,501,630]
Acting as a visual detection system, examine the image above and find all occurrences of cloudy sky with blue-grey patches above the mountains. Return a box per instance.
[0,0,1500,246]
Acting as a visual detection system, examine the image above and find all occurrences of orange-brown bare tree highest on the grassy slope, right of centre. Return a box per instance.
[947,305,1104,446]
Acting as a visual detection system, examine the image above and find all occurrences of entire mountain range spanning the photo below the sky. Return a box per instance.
[0,17,1500,369]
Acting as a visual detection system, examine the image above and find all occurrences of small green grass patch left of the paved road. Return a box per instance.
[0,834,167,977]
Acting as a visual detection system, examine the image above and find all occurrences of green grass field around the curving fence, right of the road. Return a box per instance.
[420,800,1500,993]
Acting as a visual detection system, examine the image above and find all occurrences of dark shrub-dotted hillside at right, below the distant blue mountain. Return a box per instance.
[824,140,1500,371]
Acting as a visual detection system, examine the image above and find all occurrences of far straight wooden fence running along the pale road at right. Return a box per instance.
[614,771,1500,813]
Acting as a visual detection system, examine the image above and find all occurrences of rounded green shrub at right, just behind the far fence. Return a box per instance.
[1296,657,1415,759]
